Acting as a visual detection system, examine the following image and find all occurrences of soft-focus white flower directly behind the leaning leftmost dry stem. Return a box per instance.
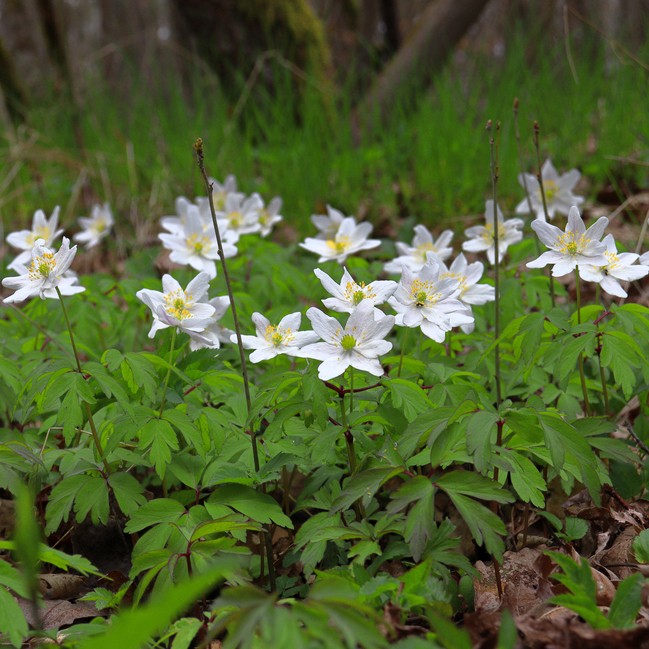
[158,205,237,278]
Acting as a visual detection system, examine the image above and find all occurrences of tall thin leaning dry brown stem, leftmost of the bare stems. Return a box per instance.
[194,137,275,591]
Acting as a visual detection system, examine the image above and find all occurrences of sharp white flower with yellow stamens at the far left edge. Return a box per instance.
[2,237,86,303]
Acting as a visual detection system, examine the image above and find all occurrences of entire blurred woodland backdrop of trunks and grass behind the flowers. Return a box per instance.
[0,0,649,247]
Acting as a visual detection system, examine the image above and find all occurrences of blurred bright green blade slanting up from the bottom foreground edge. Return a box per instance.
[78,559,237,649]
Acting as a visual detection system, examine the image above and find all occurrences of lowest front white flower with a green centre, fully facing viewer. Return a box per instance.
[299,300,394,381]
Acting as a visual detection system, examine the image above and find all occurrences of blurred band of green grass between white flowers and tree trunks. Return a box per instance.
[0,32,649,243]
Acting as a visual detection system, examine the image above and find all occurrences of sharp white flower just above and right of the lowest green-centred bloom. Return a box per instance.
[388,253,473,343]
